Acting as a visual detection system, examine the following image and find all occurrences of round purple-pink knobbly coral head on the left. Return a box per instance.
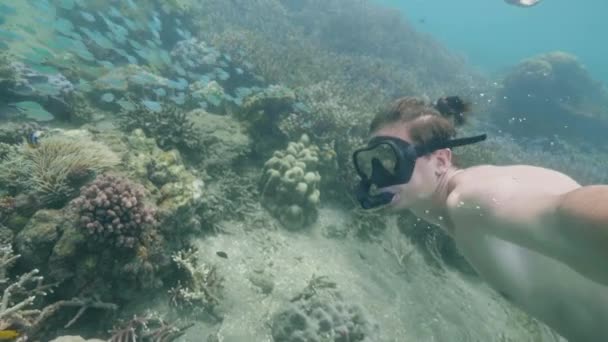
[74,175,157,248]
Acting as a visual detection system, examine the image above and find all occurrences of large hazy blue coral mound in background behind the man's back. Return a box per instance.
[495,51,608,142]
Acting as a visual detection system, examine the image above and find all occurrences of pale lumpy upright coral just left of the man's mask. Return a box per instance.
[260,135,321,230]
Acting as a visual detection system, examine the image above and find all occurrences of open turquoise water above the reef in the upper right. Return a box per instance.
[377,0,608,83]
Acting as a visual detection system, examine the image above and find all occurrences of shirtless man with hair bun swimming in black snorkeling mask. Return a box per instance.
[353,97,608,342]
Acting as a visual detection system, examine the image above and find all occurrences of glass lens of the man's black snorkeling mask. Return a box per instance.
[355,144,397,179]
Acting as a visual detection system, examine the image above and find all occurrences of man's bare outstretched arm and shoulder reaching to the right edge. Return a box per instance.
[448,182,608,286]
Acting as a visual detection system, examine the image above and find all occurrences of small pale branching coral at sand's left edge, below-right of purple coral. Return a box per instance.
[169,249,223,319]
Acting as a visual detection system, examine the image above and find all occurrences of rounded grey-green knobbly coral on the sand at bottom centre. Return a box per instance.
[272,275,379,342]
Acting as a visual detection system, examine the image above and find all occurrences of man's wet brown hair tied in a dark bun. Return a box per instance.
[370,96,470,144]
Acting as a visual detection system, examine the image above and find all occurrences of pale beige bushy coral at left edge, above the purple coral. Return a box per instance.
[0,131,119,207]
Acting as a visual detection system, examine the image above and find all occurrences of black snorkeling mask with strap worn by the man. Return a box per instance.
[353,134,486,209]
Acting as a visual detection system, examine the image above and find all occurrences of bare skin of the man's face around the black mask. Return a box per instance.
[374,124,451,210]
